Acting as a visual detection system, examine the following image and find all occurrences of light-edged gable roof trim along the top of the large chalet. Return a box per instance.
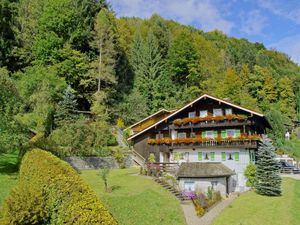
[128,94,271,140]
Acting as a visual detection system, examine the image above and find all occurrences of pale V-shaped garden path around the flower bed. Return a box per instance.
[181,195,237,225]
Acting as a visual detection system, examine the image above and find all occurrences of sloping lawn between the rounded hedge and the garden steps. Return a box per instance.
[82,168,186,225]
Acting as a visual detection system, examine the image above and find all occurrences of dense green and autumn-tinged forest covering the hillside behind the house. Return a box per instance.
[0,0,300,158]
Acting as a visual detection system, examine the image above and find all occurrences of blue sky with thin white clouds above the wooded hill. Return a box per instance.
[108,0,300,65]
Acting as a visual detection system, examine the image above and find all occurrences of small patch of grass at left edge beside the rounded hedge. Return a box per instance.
[0,153,18,209]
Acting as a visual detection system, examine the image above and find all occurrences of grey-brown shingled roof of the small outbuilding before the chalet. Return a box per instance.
[177,162,235,178]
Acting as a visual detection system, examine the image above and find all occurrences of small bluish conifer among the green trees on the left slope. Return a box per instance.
[54,86,77,126]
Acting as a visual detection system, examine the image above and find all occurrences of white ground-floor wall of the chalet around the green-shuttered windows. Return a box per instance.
[170,148,250,192]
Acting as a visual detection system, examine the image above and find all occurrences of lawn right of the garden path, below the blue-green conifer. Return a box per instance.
[213,178,300,225]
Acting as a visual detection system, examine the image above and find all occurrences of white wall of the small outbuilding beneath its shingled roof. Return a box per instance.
[179,177,226,196]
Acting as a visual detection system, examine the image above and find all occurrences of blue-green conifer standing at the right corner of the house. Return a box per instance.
[255,139,281,196]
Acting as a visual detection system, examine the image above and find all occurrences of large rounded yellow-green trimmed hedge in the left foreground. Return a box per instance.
[0,149,117,225]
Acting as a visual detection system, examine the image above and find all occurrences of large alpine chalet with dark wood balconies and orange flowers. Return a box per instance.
[128,94,271,195]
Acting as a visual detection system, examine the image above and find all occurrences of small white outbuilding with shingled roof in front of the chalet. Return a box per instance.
[177,162,235,196]
